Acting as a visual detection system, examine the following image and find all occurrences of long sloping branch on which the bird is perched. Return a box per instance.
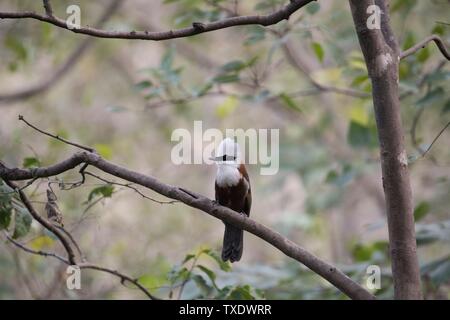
[0,151,374,299]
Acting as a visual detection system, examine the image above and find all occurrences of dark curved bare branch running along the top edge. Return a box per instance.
[0,0,316,41]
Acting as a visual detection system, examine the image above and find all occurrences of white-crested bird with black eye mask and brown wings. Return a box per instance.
[211,138,252,262]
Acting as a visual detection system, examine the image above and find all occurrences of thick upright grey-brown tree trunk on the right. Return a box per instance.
[350,0,422,299]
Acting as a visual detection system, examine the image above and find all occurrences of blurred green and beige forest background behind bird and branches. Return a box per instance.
[0,0,450,299]
